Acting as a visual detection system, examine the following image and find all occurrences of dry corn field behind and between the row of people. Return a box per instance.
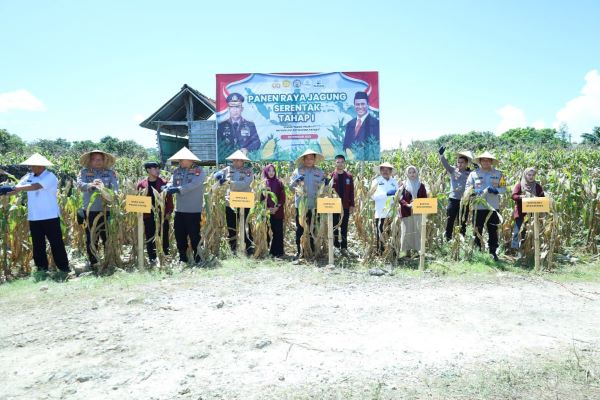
[0,147,600,281]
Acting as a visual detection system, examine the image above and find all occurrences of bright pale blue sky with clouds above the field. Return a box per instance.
[0,0,600,148]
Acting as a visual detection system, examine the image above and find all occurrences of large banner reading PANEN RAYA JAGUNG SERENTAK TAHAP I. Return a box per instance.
[216,72,380,162]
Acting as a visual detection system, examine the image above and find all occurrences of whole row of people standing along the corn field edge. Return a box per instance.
[0,147,544,274]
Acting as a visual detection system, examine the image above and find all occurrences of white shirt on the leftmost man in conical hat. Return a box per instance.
[17,169,60,221]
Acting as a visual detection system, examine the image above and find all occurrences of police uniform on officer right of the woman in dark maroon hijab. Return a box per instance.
[290,167,325,255]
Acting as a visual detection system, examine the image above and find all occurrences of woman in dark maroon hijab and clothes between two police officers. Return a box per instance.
[263,164,285,258]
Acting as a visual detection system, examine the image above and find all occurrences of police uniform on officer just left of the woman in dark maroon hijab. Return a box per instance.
[215,166,254,253]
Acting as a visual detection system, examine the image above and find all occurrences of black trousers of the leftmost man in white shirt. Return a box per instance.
[29,218,70,272]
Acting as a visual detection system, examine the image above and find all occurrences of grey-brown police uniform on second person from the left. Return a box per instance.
[77,168,119,264]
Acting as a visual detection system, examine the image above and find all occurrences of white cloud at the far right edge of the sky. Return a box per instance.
[553,69,600,138]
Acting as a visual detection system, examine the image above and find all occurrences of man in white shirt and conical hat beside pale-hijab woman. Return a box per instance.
[370,162,398,254]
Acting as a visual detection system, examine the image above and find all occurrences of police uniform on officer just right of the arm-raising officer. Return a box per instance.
[466,167,506,257]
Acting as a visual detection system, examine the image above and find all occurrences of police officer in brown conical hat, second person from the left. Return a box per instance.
[77,150,119,267]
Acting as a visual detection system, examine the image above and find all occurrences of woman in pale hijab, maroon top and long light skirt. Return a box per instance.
[400,165,427,255]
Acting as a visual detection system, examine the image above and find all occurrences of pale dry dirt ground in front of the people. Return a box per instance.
[0,263,600,399]
